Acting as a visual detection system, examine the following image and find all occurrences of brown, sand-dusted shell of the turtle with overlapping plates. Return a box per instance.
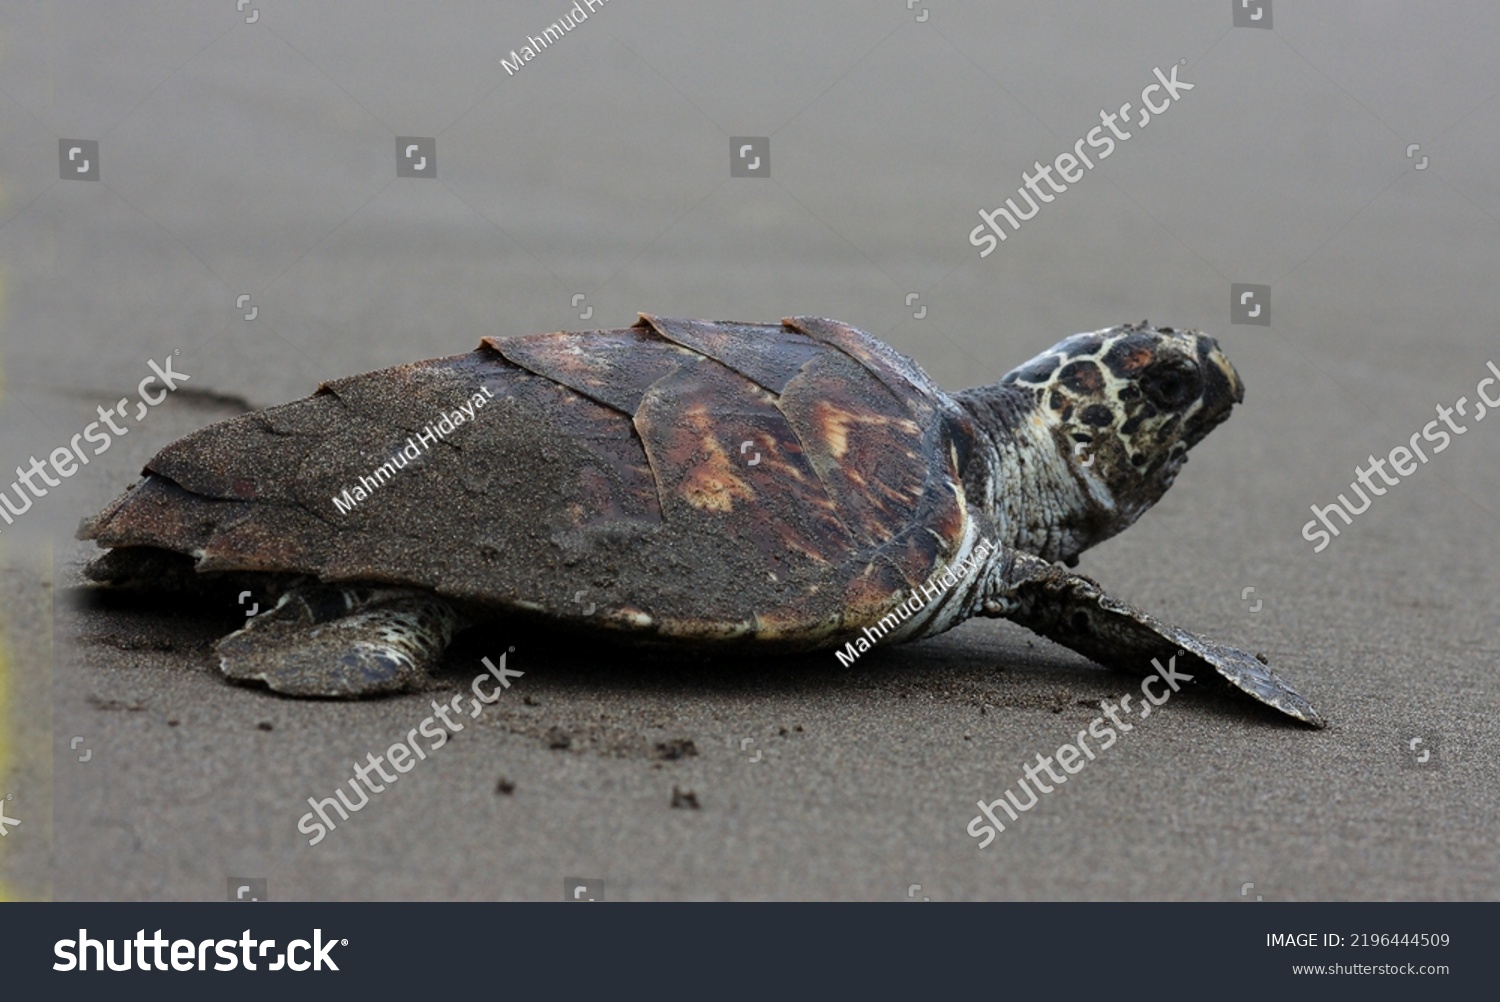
[81,315,975,647]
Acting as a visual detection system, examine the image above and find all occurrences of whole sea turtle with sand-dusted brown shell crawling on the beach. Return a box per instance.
[80,314,1323,726]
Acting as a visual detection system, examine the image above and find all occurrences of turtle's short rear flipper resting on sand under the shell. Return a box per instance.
[218,585,461,699]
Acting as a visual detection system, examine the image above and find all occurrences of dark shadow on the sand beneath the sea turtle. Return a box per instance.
[67,585,1305,731]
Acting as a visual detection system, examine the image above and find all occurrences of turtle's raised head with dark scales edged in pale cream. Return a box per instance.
[972,321,1245,564]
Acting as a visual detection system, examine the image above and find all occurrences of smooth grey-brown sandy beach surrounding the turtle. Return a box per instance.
[0,0,1500,902]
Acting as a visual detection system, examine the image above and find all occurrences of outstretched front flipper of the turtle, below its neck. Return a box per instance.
[981,551,1328,728]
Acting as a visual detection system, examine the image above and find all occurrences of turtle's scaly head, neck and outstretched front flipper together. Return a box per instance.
[942,324,1325,728]
